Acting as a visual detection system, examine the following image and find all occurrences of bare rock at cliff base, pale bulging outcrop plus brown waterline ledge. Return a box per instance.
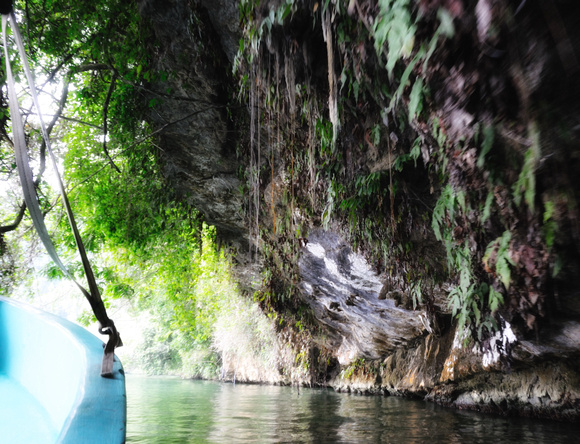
[299,230,580,421]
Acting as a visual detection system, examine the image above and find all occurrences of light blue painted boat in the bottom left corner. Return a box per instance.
[0,297,127,444]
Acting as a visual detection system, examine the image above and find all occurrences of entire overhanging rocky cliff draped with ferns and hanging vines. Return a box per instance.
[141,0,580,420]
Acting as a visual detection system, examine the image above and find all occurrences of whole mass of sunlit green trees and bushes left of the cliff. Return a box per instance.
[0,1,279,378]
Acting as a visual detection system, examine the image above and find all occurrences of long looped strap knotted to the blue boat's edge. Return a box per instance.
[0,0,123,377]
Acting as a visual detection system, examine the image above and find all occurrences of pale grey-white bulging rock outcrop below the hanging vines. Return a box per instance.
[299,230,426,364]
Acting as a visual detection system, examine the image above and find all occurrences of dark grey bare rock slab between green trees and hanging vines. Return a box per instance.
[140,0,247,250]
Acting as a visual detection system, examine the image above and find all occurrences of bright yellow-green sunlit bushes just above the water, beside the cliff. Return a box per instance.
[94,219,275,378]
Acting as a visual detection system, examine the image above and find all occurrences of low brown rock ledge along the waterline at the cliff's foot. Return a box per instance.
[329,324,580,422]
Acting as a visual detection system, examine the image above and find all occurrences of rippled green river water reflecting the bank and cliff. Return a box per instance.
[127,375,580,444]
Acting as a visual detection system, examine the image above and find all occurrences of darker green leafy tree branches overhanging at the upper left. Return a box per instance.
[0,0,165,260]
